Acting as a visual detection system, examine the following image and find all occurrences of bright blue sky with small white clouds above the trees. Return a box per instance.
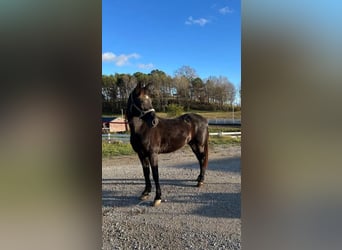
[102,0,241,87]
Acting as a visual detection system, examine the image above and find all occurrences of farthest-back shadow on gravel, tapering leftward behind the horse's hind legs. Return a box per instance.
[170,155,241,172]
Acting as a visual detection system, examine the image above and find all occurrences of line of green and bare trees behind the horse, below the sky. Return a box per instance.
[101,66,241,113]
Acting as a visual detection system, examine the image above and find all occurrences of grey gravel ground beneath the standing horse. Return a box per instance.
[102,146,241,250]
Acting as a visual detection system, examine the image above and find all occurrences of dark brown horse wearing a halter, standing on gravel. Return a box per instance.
[126,84,209,206]
